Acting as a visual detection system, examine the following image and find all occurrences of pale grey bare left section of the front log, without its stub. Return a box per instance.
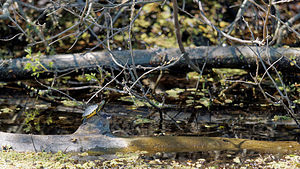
[0,132,128,152]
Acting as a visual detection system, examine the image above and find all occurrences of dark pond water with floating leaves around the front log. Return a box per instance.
[0,70,300,166]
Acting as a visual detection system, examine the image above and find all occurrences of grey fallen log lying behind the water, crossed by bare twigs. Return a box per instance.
[0,46,300,81]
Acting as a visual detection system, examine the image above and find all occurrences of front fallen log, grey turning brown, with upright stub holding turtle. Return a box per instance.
[0,116,300,154]
